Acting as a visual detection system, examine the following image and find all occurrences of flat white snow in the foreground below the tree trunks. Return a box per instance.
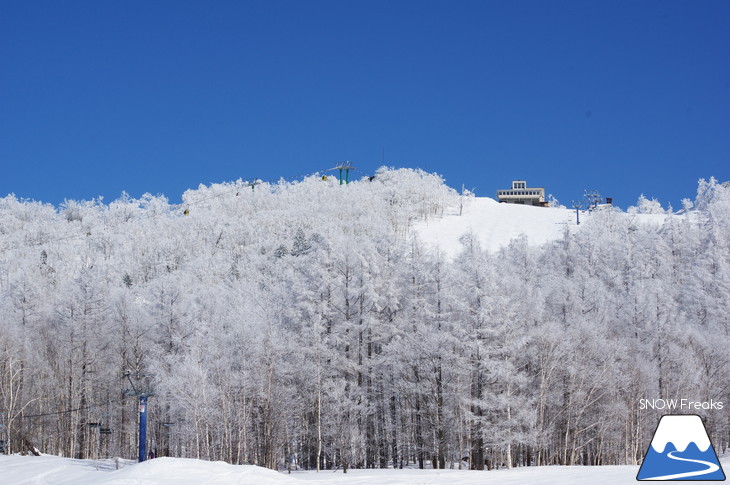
[0,455,730,485]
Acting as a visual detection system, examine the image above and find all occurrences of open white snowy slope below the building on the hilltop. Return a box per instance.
[414,197,666,258]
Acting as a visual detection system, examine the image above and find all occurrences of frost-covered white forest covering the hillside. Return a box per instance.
[0,168,730,469]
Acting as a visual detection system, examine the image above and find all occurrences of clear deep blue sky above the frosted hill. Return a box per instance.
[0,0,730,208]
